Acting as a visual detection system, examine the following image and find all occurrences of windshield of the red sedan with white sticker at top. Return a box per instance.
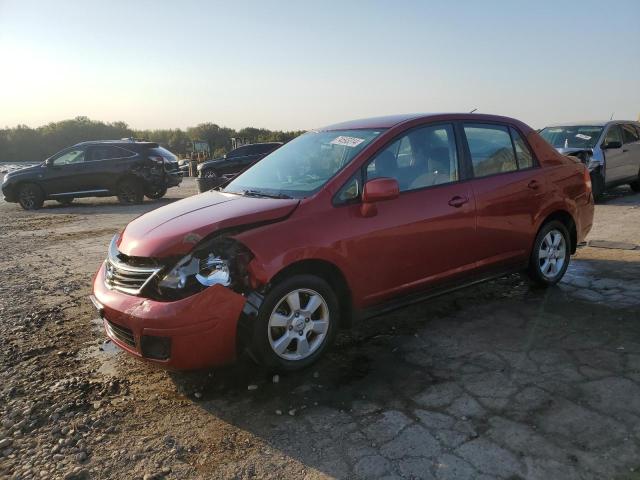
[224,130,382,198]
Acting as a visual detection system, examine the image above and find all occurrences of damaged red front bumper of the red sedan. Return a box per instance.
[91,264,245,370]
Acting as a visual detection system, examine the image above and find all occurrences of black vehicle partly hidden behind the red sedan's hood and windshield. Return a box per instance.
[196,142,282,192]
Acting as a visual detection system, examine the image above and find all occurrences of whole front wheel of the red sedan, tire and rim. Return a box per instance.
[250,275,340,371]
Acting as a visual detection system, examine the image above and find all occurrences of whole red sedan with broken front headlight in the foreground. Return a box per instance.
[92,114,593,369]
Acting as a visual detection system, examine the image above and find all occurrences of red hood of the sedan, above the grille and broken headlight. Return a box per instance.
[118,191,299,258]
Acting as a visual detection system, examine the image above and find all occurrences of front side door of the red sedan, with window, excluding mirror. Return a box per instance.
[338,123,475,304]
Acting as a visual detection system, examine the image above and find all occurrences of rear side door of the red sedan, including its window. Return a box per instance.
[463,122,546,270]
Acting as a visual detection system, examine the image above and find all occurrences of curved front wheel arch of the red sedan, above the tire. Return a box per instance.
[269,259,353,328]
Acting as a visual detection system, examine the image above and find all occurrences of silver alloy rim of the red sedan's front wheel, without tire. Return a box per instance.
[268,288,330,361]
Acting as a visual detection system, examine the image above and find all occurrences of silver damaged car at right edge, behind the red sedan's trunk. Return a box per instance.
[540,124,640,199]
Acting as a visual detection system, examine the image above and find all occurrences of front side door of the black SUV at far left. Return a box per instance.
[42,147,85,198]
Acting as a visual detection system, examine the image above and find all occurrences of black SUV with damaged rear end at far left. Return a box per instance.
[2,140,182,210]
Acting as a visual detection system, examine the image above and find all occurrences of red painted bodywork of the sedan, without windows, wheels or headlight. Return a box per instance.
[94,114,594,369]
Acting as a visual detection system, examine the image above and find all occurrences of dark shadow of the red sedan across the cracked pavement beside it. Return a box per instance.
[166,261,640,478]
